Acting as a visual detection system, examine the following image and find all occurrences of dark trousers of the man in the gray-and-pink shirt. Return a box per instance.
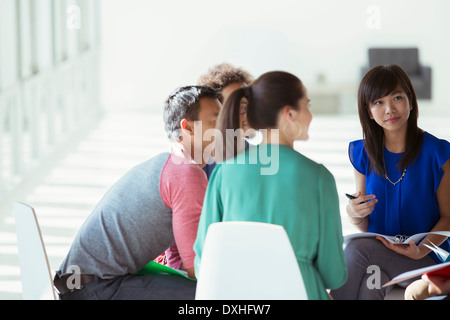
[60,274,197,300]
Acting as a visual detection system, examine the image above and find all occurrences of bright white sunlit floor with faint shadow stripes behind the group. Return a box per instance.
[0,110,450,300]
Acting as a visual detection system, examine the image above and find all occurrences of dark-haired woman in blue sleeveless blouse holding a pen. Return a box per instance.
[331,65,450,299]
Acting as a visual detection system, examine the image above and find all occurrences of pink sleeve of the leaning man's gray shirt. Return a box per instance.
[160,143,208,269]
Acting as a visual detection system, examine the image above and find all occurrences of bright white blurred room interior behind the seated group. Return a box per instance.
[0,0,450,299]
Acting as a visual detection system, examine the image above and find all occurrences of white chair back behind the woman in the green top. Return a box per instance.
[195,222,308,300]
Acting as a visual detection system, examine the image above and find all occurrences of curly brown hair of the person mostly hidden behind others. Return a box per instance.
[197,63,253,90]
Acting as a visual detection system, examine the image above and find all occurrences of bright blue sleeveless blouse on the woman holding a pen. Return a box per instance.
[349,132,450,262]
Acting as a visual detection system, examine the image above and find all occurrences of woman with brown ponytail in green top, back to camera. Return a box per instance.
[194,72,347,300]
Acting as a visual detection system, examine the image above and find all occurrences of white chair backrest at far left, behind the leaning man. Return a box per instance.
[14,202,56,300]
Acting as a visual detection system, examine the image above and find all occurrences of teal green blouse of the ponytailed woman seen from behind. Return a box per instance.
[194,145,347,300]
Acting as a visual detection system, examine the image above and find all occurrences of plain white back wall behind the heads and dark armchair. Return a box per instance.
[102,0,450,115]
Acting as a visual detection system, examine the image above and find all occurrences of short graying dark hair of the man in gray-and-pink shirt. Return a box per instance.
[163,86,222,141]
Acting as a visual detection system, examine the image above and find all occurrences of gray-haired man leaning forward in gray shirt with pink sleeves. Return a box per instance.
[54,86,221,300]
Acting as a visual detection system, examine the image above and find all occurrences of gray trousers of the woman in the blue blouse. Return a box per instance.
[330,238,435,300]
